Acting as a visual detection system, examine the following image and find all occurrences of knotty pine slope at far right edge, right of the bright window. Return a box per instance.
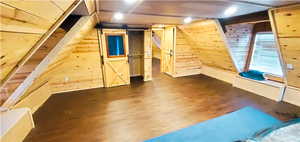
[270,5,300,88]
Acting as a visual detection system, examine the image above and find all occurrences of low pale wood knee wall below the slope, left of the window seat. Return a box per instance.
[201,66,237,84]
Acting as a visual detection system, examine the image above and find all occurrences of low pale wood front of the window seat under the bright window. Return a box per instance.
[233,75,285,101]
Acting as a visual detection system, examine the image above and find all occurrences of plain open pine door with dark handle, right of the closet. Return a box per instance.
[161,27,175,75]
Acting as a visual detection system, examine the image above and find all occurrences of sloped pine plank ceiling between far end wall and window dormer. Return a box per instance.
[178,20,237,72]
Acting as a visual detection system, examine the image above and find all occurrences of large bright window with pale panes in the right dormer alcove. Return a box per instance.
[249,32,283,76]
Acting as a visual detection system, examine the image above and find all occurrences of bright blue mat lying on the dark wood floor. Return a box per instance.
[145,107,282,142]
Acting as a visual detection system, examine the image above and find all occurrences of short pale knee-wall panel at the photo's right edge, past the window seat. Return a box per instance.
[283,86,300,106]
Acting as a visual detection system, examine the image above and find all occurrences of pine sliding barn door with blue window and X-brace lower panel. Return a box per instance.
[101,29,130,87]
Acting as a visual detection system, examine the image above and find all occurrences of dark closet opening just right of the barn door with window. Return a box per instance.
[128,31,144,82]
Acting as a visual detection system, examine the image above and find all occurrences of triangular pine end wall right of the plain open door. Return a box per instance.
[175,28,201,76]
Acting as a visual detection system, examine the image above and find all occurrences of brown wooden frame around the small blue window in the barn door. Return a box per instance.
[105,33,127,58]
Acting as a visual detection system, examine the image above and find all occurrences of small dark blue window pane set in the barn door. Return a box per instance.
[106,35,125,57]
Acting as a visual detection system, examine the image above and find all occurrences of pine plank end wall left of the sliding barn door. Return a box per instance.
[50,29,103,93]
